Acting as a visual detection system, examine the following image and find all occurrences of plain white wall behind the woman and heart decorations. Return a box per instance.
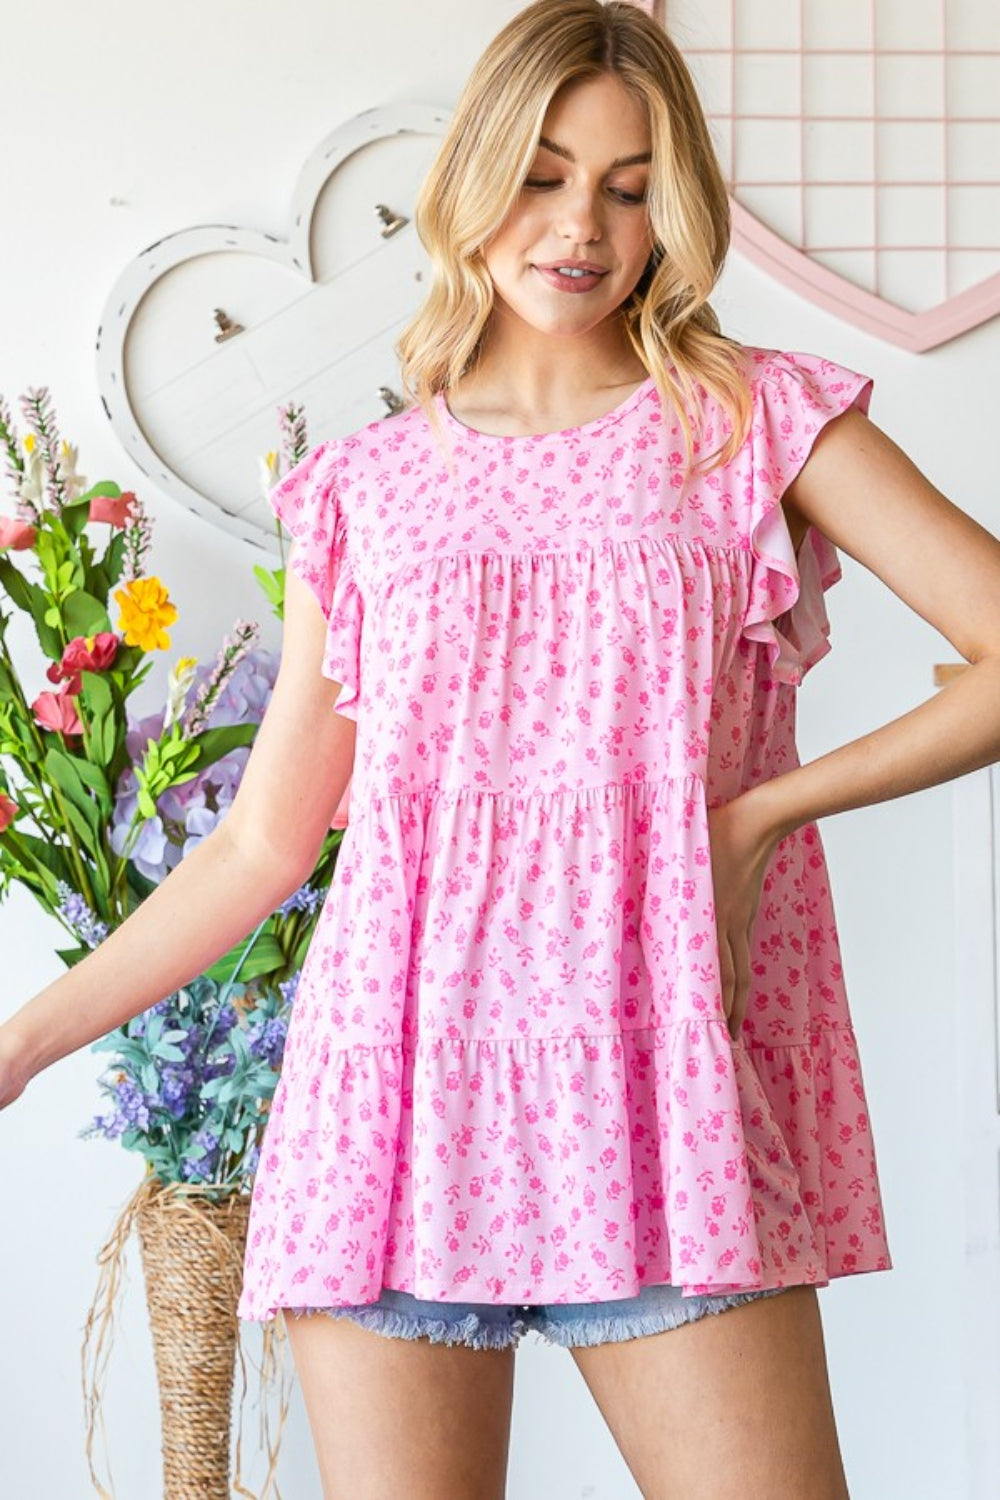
[0,0,1000,1500]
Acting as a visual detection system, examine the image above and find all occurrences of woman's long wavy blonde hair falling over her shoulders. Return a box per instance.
[394,0,750,471]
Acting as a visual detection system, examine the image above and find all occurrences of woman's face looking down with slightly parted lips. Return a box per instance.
[483,74,654,335]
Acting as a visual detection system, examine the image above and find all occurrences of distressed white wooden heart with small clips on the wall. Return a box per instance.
[97,104,451,549]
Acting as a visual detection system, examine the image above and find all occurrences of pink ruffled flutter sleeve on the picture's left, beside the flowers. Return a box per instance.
[268,440,364,720]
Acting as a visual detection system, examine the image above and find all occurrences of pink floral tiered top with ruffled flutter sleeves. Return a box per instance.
[238,350,892,1322]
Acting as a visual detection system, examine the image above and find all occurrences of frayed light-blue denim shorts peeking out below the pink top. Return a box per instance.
[285,1284,784,1349]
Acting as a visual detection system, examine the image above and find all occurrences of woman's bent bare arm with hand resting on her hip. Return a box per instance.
[747,411,1000,839]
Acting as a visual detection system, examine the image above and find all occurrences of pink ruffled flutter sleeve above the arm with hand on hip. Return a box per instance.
[744,353,873,686]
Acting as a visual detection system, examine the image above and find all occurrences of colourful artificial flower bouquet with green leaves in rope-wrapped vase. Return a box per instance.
[0,387,343,1188]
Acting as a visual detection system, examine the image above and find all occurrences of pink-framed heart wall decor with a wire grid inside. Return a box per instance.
[650,0,1000,350]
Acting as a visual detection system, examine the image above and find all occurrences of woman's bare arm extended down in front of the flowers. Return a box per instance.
[0,570,355,1106]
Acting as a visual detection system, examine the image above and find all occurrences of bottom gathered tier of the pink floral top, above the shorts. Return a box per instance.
[238,1020,892,1320]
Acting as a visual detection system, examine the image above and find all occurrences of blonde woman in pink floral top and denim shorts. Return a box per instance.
[0,0,1000,1500]
